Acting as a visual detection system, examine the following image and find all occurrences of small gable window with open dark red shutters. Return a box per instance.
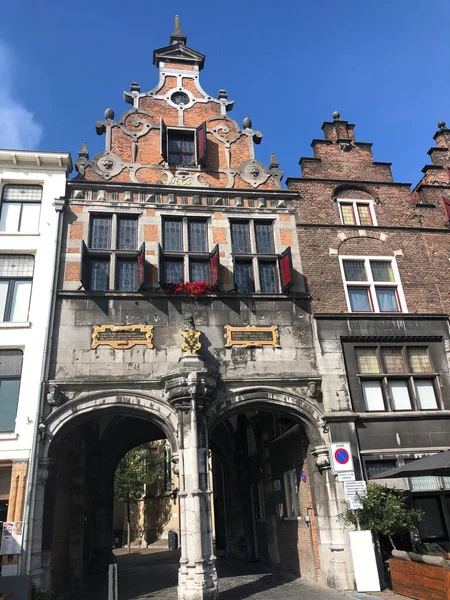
[160,119,207,167]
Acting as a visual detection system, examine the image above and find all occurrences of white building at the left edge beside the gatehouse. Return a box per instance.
[0,150,72,574]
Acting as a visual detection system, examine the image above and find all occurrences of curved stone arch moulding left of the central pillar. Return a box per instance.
[43,389,178,457]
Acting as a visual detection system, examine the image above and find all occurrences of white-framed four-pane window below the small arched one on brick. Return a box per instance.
[341,257,405,312]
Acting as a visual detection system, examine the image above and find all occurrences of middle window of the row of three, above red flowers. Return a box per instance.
[159,217,220,286]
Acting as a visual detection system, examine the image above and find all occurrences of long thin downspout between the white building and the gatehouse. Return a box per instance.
[19,197,66,575]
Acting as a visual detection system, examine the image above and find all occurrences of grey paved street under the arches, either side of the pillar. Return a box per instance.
[117,550,347,600]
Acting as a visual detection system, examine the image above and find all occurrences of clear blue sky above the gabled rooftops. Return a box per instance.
[0,0,450,183]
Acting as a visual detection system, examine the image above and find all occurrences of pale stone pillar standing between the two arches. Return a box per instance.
[166,354,218,600]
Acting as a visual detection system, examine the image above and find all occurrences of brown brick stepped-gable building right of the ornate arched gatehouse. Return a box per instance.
[287,113,450,542]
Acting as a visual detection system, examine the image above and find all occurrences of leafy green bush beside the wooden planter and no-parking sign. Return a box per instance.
[339,483,423,548]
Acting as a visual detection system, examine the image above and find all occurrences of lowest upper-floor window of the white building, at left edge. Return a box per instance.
[0,350,22,433]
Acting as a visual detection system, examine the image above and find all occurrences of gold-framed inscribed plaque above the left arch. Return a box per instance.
[91,325,153,350]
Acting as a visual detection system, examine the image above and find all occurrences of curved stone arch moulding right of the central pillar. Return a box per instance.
[207,387,327,447]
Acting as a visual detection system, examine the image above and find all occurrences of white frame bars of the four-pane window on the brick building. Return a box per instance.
[339,256,408,314]
